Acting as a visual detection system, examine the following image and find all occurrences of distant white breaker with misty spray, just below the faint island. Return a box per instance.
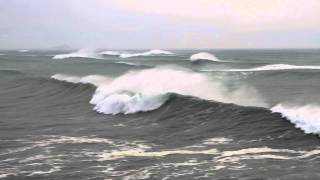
[52,49,101,59]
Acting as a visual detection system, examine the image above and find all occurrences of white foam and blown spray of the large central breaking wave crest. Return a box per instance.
[52,68,265,114]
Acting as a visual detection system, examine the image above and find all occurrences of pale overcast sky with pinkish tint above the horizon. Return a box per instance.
[0,0,320,49]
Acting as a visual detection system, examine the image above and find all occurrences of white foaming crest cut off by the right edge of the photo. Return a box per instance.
[271,104,320,135]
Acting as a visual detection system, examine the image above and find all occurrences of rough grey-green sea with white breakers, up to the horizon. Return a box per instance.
[0,49,320,180]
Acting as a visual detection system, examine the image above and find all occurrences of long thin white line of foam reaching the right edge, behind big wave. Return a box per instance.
[201,64,320,72]
